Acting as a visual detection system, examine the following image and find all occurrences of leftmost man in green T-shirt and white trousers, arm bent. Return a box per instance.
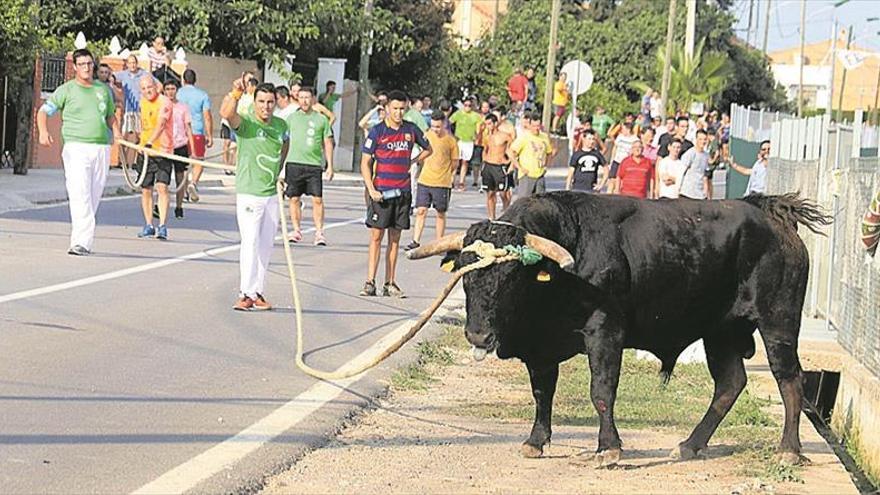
[37,50,121,256]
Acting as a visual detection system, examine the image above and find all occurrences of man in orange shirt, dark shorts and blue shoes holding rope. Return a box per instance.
[138,76,174,241]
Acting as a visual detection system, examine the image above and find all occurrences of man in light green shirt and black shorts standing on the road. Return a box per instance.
[284,87,333,246]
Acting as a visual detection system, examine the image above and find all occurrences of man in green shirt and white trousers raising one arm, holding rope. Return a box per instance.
[220,79,290,311]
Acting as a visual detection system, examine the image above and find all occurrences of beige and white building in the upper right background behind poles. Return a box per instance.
[767,31,880,110]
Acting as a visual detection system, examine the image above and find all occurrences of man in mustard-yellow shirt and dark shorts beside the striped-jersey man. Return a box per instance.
[405,110,459,251]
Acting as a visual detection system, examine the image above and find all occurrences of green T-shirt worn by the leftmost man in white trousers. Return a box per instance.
[46,79,116,144]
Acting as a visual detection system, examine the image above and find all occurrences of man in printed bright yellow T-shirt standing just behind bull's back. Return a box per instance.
[510,112,556,198]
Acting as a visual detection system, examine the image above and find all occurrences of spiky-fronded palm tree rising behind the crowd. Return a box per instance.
[632,38,733,111]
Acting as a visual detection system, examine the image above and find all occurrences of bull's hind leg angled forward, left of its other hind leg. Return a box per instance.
[672,332,751,460]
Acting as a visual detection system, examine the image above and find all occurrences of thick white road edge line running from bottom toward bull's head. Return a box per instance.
[134,289,464,495]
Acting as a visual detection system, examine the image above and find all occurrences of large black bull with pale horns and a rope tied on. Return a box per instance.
[409,192,829,465]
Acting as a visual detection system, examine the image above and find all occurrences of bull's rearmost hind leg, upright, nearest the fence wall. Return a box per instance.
[759,326,806,464]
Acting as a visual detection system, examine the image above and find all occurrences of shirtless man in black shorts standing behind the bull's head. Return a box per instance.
[483,113,513,220]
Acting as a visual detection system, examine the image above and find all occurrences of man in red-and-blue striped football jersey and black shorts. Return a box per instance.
[360,91,431,297]
